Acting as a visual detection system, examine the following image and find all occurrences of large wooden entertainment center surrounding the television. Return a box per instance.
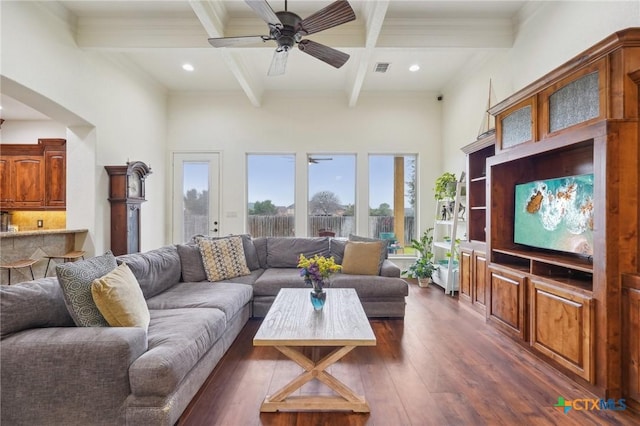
[460,28,640,406]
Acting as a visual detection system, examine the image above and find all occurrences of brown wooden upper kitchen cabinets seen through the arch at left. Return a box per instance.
[0,139,66,210]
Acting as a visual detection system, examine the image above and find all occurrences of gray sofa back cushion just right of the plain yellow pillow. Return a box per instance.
[117,245,182,299]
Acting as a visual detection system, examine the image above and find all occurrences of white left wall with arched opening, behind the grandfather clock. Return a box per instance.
[0,1,167,253]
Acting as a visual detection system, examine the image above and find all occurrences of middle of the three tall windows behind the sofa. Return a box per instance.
[307,154,356,237]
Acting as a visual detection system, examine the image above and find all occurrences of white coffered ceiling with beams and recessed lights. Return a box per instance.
[1,0,538,118]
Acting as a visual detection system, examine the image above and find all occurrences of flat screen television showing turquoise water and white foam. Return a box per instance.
[513,174,593,256]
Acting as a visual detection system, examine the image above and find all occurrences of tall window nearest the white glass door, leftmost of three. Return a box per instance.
[247,154,295,237]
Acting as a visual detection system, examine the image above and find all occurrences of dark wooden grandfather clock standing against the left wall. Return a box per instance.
[104,161,151,256]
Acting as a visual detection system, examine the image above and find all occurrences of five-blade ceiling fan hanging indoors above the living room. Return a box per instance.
[209,0,356,75]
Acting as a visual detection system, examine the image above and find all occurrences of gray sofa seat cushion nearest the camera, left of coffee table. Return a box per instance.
[129,308,226,397]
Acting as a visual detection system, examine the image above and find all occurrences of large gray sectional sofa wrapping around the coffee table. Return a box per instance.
[0,236,408,426]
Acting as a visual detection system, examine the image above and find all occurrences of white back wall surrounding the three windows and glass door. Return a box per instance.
[167,93,442,235]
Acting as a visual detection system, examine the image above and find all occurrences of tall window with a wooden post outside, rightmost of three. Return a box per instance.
[369,155,416,254]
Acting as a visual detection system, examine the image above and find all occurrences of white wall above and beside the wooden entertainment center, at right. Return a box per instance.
[442,0,640,170]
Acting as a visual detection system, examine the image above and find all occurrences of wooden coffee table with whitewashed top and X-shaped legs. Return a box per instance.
[253,288,376,413]
